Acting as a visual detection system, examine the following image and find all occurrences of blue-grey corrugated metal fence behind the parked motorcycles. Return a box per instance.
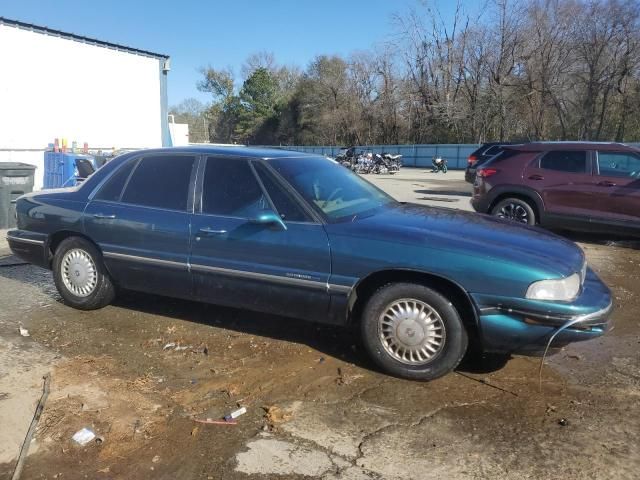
[271,143,478,169]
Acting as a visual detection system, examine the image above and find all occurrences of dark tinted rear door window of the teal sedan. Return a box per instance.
[122,155,195,211]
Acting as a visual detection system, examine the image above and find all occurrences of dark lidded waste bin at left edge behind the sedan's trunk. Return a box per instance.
[0,162,36,229]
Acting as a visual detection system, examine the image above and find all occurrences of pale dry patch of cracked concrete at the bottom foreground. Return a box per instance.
[236,401,490,479]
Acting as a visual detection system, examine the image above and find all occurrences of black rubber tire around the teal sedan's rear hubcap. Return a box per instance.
[52,237,116,310]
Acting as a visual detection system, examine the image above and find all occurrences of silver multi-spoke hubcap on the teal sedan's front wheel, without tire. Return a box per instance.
[378,298,445,365]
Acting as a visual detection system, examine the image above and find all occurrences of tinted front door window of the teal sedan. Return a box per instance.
[202,157,271,218]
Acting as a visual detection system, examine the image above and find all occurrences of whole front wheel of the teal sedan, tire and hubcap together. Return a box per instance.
[361,283,468,380]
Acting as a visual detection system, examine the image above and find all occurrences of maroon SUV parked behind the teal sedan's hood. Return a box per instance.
[471,142,640,235]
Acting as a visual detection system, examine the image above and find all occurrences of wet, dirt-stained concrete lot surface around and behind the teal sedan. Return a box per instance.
[0,169,640,480]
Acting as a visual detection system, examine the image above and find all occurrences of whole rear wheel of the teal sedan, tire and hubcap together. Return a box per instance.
[53,237,115,310]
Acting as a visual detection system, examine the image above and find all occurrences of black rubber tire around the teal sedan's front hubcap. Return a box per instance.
[360,283,469,381]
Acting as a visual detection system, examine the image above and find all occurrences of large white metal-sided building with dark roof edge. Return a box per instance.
[0,17,171,189]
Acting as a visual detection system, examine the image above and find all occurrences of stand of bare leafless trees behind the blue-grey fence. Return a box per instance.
[199,0,640,144]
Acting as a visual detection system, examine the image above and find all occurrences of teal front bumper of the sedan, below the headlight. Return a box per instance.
[472,269,613,354]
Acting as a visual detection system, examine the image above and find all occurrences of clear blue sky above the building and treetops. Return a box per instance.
[0,0,480,106]
